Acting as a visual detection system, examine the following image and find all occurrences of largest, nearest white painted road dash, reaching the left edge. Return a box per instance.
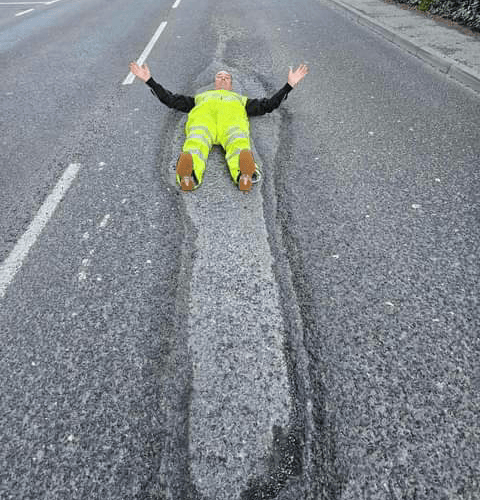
[0,163,80,298]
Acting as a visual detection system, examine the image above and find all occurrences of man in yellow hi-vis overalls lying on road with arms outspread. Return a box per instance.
[130,62,308,191]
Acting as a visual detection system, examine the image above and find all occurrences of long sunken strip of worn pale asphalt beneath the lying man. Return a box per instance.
[154,63,316,500]
